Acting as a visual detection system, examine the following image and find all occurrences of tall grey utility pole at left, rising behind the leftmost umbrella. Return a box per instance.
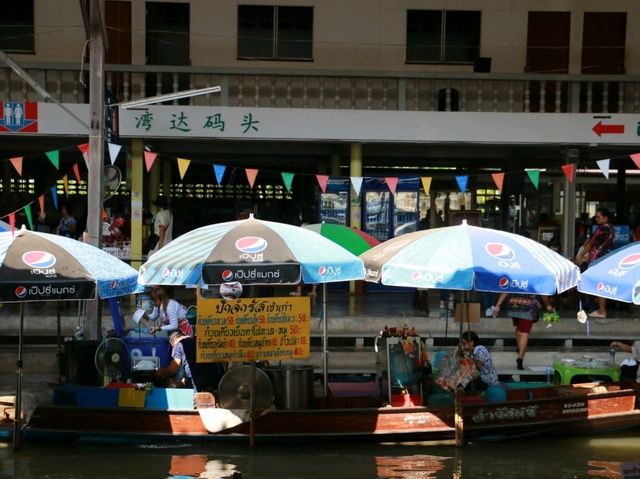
[80,0,107,339]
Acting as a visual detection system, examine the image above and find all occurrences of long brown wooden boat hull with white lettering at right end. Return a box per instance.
[5,383,640,443]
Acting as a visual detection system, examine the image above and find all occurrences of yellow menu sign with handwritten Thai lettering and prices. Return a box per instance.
[196,296,311,363]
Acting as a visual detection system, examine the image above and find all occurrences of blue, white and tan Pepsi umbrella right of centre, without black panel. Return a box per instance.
[360,222,580,295]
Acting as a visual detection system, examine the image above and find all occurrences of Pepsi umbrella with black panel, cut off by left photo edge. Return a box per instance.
[0,230,138,303]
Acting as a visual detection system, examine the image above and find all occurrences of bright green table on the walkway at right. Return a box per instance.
[553,357,620,385]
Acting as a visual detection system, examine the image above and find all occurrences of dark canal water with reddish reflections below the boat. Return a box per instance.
[0,430,640,479]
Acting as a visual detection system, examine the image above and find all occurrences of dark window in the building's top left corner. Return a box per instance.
[0,0,35,53]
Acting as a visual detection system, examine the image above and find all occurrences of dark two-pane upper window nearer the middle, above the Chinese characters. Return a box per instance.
[238,5,313,60]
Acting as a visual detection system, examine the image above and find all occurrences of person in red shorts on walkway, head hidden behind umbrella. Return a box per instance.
[493,293,553,371]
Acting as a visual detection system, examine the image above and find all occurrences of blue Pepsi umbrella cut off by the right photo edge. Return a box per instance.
[578,242,640,304]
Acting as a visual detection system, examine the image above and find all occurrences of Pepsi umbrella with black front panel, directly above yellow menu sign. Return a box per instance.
[139,217,364,286]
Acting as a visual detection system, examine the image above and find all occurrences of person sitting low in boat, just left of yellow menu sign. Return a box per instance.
[156,331,224,392]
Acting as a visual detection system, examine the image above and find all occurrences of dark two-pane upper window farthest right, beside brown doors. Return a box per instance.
[406,10,480,63]
